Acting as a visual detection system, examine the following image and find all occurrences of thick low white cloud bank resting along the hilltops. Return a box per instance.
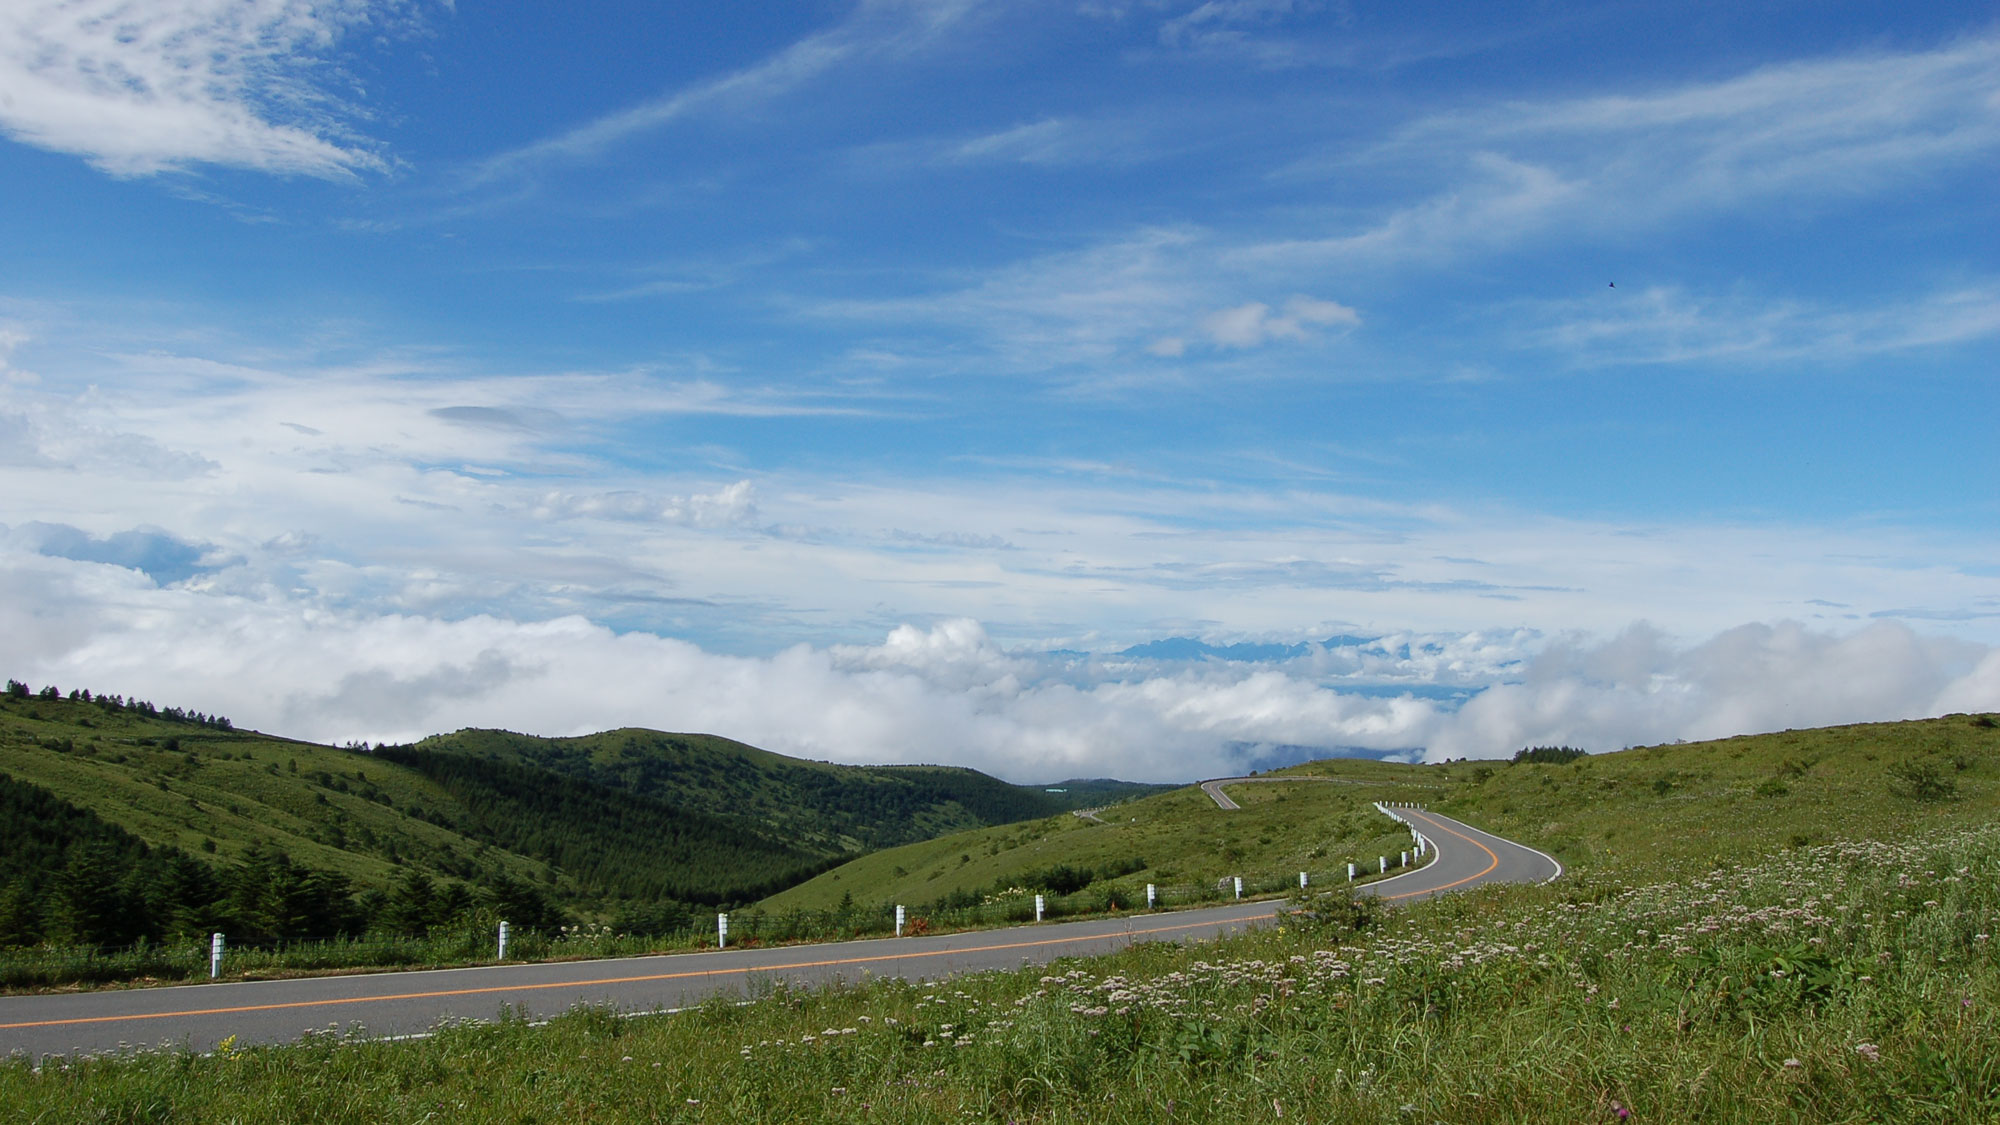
[0,554,2000,781]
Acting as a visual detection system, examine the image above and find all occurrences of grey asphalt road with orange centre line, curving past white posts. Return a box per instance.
[0,809,1562,1059]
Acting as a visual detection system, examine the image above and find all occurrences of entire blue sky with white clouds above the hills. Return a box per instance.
[0,0,2000,779]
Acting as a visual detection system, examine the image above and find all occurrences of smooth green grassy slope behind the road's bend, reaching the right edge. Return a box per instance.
[760,715,2000,911]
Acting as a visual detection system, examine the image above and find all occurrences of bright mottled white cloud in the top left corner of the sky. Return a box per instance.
[0,0,392,178]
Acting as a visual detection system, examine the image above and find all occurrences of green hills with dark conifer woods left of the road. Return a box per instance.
[0,683,1152,945]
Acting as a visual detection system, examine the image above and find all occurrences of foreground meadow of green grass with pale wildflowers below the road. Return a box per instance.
[0,804,2000,1123]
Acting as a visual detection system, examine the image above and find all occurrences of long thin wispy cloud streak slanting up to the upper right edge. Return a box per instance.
[1228,38,2000,268]
